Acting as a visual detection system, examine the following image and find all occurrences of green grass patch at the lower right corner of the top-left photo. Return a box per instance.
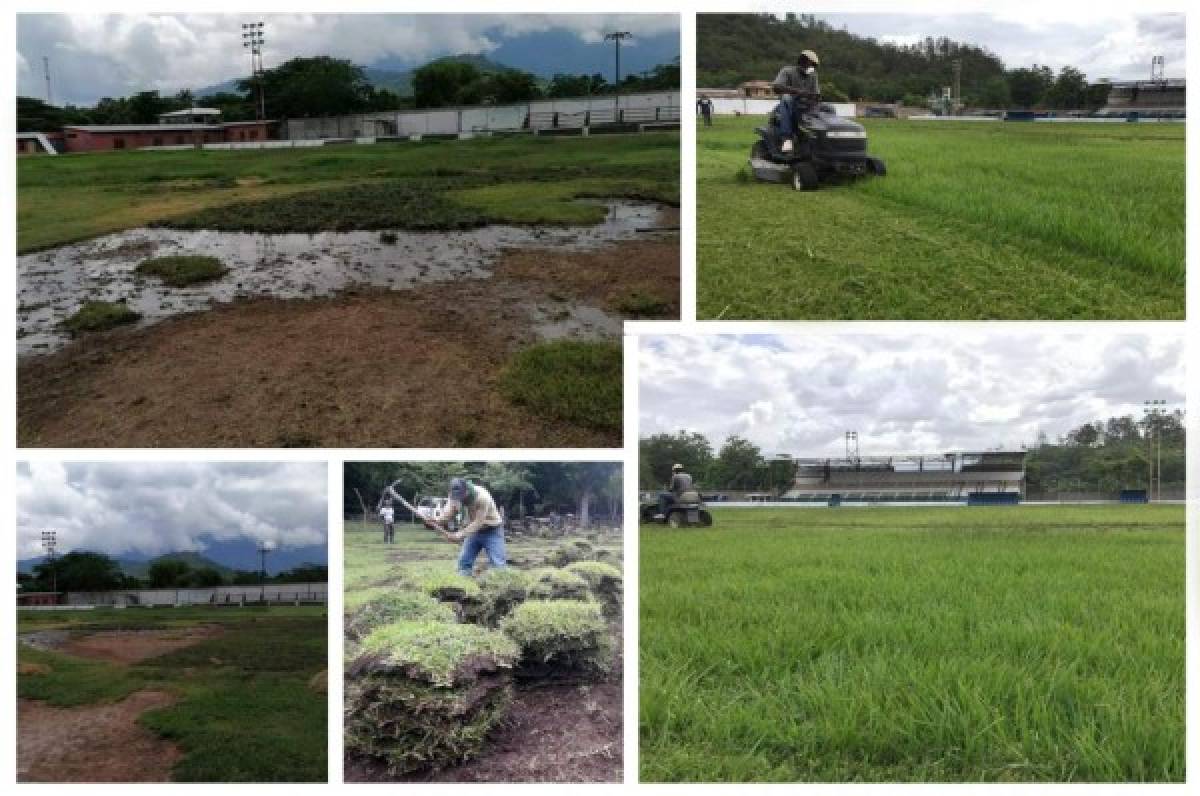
[500,340,623,431]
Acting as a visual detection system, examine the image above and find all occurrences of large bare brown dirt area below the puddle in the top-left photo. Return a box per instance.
[17,239,679,448]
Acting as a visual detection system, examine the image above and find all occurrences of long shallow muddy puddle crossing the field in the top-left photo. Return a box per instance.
[17,201,662,355]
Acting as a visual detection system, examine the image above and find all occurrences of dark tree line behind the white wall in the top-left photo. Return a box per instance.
[17,55,679,132]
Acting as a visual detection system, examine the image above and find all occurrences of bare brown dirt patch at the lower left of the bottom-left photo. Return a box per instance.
[17,690,182,783]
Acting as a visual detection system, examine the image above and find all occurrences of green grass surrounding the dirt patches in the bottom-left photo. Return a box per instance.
[17,606,328,783]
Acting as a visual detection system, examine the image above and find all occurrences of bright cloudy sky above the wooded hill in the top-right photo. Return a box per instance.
[817,10,1186,80]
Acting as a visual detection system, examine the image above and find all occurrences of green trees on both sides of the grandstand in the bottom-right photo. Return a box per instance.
[637,411,1187,495]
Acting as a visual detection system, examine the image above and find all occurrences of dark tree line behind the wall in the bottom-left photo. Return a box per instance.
[17,550,329,592]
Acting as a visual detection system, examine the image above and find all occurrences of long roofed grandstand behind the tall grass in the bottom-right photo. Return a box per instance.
[780,450,1025,502]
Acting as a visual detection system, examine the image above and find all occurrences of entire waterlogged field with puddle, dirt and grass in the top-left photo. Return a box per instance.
[17,133,679,447]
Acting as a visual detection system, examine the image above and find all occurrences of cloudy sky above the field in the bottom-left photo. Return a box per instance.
[16,462,328,559]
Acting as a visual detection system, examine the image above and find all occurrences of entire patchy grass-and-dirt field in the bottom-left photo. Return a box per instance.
[17,606,328,783]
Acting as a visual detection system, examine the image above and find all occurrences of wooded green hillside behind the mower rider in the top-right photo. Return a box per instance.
[696,13,1109,109]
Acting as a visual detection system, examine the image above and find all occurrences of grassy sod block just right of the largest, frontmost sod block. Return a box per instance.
[500,600,613,681]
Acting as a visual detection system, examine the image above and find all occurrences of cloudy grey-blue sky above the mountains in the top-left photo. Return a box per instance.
[17,13,679,104]
